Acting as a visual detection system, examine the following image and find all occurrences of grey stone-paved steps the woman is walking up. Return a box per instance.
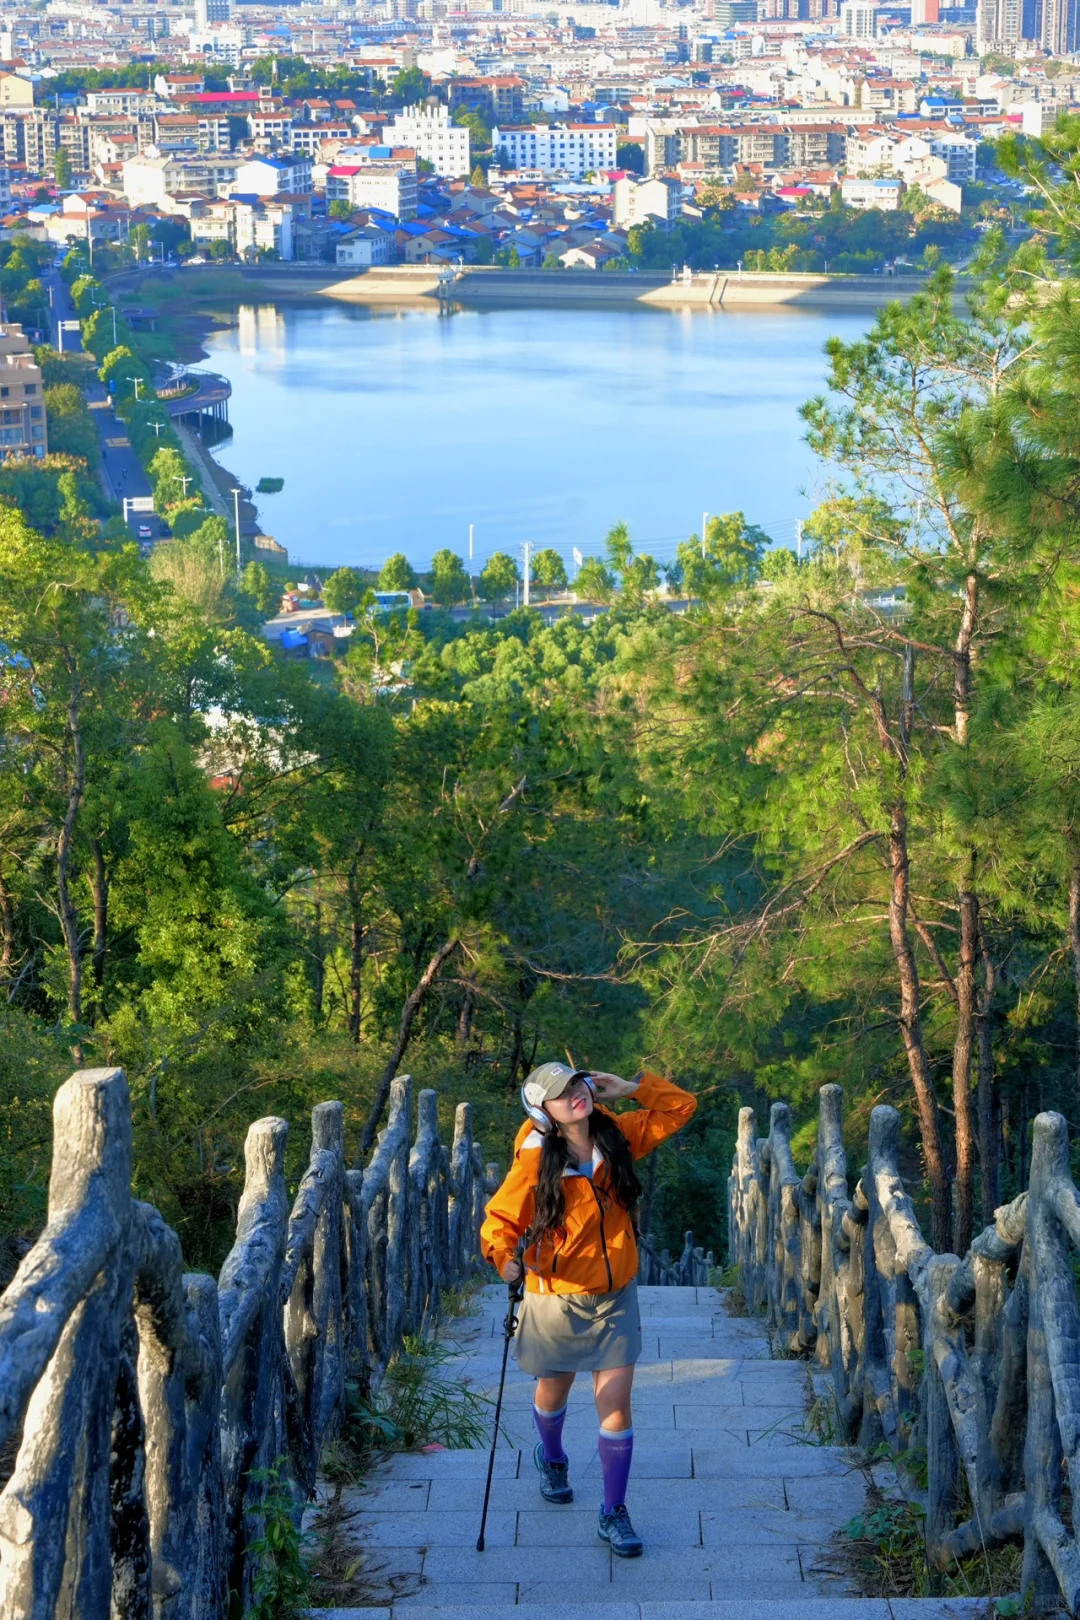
[313,1285,993,1620]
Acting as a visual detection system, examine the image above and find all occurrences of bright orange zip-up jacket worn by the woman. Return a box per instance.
[479,1069,698,1294]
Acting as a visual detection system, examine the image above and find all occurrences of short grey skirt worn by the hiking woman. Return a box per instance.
[513,1278,641,1379]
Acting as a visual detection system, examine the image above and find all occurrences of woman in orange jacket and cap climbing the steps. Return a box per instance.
[481,1063,698,1558]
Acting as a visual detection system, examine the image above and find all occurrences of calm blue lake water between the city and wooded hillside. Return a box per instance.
[207,303,870,572]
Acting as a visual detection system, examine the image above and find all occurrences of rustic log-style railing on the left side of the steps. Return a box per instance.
[0,1069,495,1620]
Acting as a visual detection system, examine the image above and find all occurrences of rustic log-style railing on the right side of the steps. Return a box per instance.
[729,1085,1080,1614]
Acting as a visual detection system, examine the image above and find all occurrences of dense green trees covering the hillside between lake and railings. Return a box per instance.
[0,126,1080,1265]
